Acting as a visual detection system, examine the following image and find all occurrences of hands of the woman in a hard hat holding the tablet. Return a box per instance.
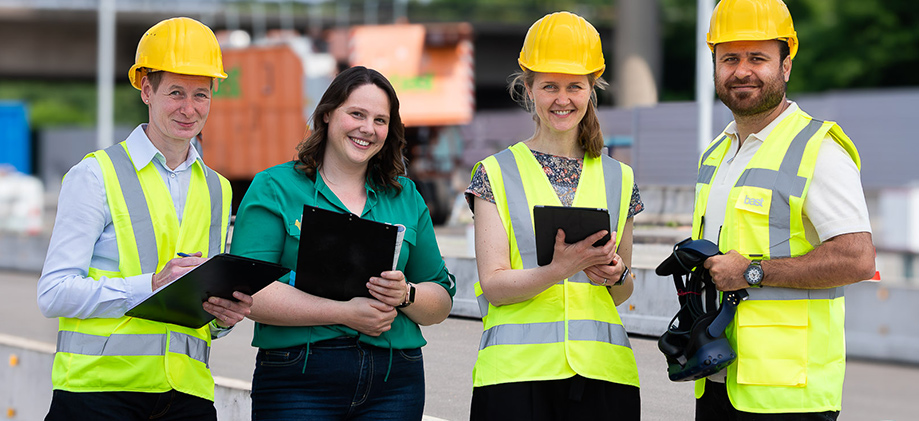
[549,229,619,282]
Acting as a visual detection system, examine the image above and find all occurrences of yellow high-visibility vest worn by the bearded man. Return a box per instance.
[693,110,861,413]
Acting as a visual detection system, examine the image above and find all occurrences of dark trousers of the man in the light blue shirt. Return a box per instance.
[45,390,217,421]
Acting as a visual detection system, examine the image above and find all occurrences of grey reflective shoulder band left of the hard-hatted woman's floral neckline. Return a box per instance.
[495,149,538,269]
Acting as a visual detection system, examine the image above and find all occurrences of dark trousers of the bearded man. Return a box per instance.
[696,379,839,421]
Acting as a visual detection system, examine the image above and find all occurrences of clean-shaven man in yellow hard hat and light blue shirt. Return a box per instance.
[38,18,252,421]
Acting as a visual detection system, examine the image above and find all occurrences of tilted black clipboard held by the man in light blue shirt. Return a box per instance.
[125,253,290,329]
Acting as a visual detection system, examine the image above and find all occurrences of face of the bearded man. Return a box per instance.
[715,41,791,116]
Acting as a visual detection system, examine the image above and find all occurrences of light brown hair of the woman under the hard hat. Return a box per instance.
[507,69,609,158]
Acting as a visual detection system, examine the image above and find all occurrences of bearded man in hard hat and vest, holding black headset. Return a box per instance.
[693,0,875,421]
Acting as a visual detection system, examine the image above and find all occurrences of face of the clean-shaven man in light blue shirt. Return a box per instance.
[141,72,211,145]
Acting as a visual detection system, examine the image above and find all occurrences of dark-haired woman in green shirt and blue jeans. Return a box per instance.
[232,67,455,420]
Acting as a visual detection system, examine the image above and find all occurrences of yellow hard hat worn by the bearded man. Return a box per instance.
[706,0,798,58]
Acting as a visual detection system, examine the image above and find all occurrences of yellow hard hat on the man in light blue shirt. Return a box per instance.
[128,18,227,89]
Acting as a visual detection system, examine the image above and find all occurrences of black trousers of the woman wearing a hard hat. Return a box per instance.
[469,376,641,421]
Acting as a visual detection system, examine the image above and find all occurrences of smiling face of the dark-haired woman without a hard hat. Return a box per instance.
[323,84,389,168]
